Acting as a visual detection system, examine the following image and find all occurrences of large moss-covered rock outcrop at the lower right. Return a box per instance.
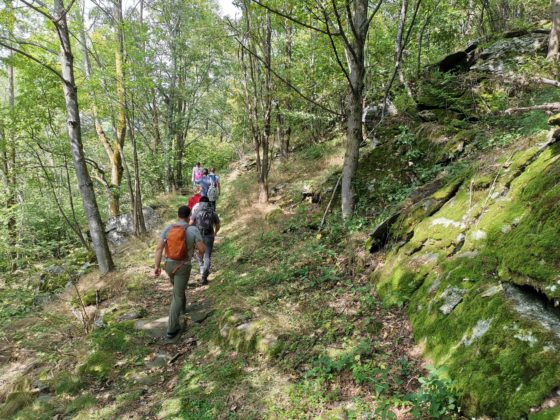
[372,133,560,419]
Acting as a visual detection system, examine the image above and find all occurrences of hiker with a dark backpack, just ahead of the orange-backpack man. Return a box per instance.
[190,197,220,285]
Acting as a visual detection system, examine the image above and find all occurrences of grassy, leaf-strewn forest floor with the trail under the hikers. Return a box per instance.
[0,139,454,419]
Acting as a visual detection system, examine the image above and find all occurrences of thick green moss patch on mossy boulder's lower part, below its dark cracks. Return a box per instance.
[409,257,560,418]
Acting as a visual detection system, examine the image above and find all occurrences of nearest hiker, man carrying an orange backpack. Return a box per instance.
[154,206,206,339]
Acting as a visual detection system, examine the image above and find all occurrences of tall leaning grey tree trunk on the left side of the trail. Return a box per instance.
[53,0,114,274]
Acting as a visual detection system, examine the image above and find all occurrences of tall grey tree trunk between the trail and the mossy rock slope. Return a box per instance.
[342,0,368,219]
